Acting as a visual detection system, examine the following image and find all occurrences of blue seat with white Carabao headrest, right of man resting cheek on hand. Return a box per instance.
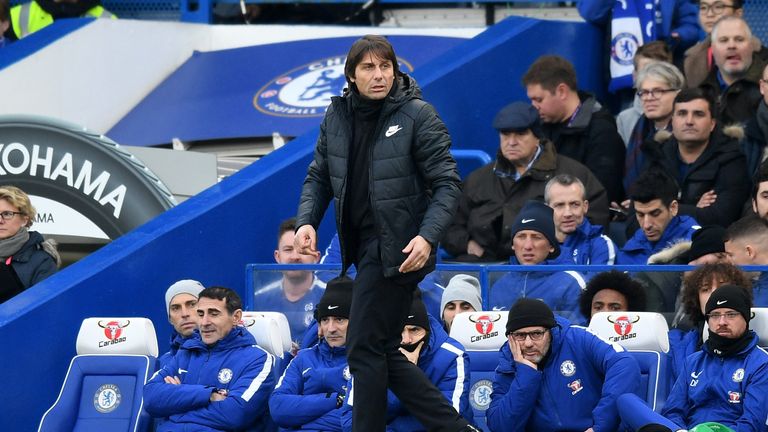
[589,312,669,411]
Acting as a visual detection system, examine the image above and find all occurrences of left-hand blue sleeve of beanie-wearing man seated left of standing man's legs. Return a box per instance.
[269,353,338,428]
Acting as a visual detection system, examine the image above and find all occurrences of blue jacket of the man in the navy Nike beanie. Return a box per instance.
[489,254,587,322]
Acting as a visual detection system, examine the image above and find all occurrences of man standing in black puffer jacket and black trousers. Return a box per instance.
[295,35,474,432]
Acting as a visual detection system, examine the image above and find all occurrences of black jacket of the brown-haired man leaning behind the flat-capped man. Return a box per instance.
[542,92,626,202]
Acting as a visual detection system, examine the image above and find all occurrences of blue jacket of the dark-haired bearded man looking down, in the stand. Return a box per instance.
[616,215,701,265]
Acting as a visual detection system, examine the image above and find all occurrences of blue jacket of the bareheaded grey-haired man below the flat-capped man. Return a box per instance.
[560,218,618,265]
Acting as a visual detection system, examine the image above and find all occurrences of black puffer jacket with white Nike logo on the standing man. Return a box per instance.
[296,75,461,277]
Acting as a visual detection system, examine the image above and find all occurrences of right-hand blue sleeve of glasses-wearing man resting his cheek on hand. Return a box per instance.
[582,331,640,432]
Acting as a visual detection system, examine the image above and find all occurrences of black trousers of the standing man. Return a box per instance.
[347,239,467,432]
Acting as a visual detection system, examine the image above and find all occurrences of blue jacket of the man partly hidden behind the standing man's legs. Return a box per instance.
[341,314,474,432]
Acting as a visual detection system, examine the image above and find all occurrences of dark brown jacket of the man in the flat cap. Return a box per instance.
[442,139,608,261]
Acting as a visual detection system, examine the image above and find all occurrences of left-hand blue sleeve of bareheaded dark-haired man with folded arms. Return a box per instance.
[144,356,213,417]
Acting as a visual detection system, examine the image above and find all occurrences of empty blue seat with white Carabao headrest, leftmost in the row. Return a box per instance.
[38,318,157,432]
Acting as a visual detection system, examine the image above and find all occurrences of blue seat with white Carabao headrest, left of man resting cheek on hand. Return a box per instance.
[451,311,509,431]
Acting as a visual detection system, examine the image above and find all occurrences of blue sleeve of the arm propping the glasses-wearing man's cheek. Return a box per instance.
[486,354,543,432]
